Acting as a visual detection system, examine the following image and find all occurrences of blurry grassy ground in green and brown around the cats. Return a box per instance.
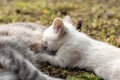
[0,0,120,80]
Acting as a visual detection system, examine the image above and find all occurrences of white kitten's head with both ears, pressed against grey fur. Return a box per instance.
[43,16,75,51]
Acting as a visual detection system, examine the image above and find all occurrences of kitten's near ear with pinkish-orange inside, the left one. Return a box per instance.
[53,18,64,32]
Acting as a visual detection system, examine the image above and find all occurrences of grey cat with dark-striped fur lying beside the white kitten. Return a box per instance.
[0,22,62,80]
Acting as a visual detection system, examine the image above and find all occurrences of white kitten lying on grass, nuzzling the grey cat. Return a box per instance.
[36,16,120,80]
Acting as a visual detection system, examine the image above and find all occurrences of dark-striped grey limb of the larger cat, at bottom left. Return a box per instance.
[0,46,62,80]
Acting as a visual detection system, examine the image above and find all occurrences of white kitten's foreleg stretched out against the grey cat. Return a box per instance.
[34,51,81,68]
